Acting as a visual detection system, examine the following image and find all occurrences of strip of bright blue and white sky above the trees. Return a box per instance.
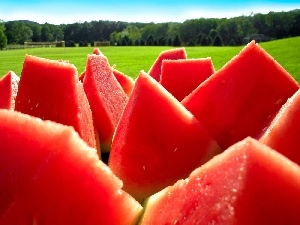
[0,0,300,24]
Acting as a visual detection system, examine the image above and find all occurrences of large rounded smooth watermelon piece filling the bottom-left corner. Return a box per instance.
[0,109,142,225]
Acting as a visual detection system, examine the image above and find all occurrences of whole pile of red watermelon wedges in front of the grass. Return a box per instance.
[0,41,300,225]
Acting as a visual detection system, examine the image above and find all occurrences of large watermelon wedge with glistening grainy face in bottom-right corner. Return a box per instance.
[139,138,300,225]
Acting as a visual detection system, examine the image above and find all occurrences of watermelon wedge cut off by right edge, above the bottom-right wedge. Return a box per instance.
[259,90,300,165]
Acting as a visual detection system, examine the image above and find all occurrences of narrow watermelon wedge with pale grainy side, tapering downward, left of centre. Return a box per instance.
[83,54,128,152]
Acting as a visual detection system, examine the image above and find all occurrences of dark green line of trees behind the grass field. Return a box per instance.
[0,9,300,49]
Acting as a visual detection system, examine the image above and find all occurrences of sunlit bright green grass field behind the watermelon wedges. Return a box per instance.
[0,37,300,82]
